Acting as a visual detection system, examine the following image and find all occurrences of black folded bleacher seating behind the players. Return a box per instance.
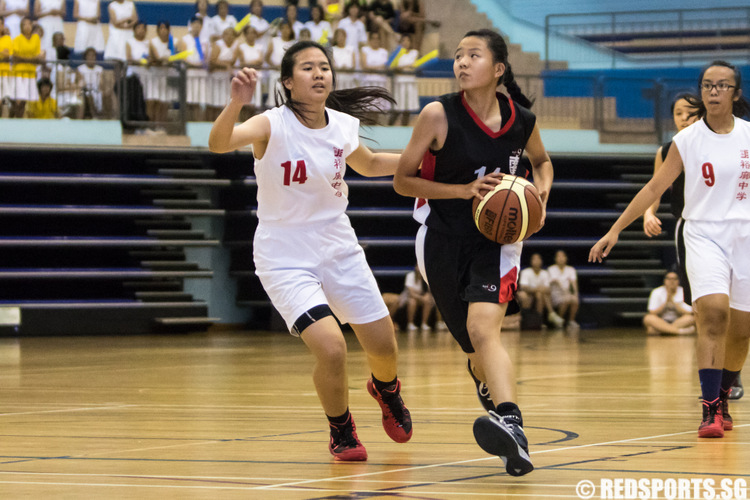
[0,147,673,335]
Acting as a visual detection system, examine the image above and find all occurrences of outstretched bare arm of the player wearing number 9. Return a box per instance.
[589,146,683,262]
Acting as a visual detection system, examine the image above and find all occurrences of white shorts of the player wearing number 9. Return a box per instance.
[684,220,750,312]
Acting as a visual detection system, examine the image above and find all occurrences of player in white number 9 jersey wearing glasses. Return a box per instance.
[589,61,750,437]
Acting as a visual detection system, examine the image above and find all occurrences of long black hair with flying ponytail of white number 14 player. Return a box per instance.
[274,40,396,125]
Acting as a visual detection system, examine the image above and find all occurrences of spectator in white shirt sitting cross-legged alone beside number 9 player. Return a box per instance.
[643,271,695,335]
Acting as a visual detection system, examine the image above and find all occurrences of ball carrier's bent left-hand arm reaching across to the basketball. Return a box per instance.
[393,102,502,200]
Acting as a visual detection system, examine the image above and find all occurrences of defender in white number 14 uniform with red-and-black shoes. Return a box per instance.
[209,41,412,461]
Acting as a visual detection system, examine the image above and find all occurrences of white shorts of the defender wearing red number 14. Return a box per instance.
[253,215,388,332]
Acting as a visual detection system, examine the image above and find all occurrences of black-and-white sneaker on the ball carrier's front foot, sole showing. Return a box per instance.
[474,411,534,476]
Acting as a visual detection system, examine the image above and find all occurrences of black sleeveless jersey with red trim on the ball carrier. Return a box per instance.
[414,92,536,234]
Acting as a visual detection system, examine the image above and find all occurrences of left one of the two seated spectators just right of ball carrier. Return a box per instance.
[516,253,565,328]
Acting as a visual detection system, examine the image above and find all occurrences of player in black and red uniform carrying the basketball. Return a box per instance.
[394,30,553,476]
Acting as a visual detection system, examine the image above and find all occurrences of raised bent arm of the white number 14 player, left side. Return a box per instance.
[208,68,271,154]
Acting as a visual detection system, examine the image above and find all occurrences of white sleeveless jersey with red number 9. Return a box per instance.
[673,117,750,221]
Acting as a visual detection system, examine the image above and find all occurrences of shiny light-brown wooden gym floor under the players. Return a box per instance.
[0,329,750,499]
